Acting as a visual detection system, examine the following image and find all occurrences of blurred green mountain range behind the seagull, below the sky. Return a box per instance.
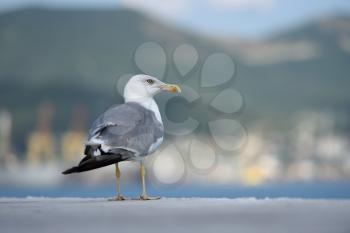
[0,9,350,149]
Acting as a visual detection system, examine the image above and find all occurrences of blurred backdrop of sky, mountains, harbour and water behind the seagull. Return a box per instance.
[0,0,350,198]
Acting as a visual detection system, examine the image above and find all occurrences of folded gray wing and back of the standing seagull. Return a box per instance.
[89,103,164,156]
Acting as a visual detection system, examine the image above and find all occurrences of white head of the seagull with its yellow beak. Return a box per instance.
[124,74,181,102]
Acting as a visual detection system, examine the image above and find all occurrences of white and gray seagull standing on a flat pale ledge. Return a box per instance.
[62,74,181,201]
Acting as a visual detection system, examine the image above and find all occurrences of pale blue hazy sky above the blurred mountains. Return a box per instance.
[0,0,350,36]
